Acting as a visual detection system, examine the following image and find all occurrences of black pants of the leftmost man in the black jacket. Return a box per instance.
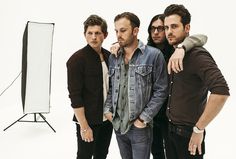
[76,120,113,159]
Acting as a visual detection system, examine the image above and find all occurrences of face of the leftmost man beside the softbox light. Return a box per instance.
[84,25,106,50]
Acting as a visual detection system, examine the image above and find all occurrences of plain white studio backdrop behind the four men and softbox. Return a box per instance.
[0,0,236,159]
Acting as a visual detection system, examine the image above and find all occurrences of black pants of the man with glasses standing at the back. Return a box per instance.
[151,118,168,159]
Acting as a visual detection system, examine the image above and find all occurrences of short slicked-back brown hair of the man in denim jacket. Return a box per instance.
[114,12,140,28]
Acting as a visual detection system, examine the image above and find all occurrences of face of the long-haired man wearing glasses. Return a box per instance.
[151,19,166,44]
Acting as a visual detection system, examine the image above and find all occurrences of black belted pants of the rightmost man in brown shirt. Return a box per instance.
[166,123,205,159]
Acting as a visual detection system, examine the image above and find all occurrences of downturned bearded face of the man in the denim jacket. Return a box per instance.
[115,18,138,47]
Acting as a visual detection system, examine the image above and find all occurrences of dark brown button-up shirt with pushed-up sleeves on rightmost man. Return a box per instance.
[166,47,229,126]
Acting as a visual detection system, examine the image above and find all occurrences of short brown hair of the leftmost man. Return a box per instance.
[84,14,107,34]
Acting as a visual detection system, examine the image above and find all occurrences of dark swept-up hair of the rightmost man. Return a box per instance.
[164,4,191,26]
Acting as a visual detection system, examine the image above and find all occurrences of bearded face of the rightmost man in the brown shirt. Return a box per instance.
[164,14,190,46]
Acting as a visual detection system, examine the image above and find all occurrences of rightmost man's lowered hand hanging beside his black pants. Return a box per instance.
[188,132,203,155]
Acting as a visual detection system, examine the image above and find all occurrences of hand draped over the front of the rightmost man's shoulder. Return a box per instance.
[168,48,185,74]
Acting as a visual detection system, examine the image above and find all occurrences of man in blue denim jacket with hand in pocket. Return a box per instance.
[104,12,168,159]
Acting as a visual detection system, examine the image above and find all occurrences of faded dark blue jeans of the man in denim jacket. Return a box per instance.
[115,125,152,159]
